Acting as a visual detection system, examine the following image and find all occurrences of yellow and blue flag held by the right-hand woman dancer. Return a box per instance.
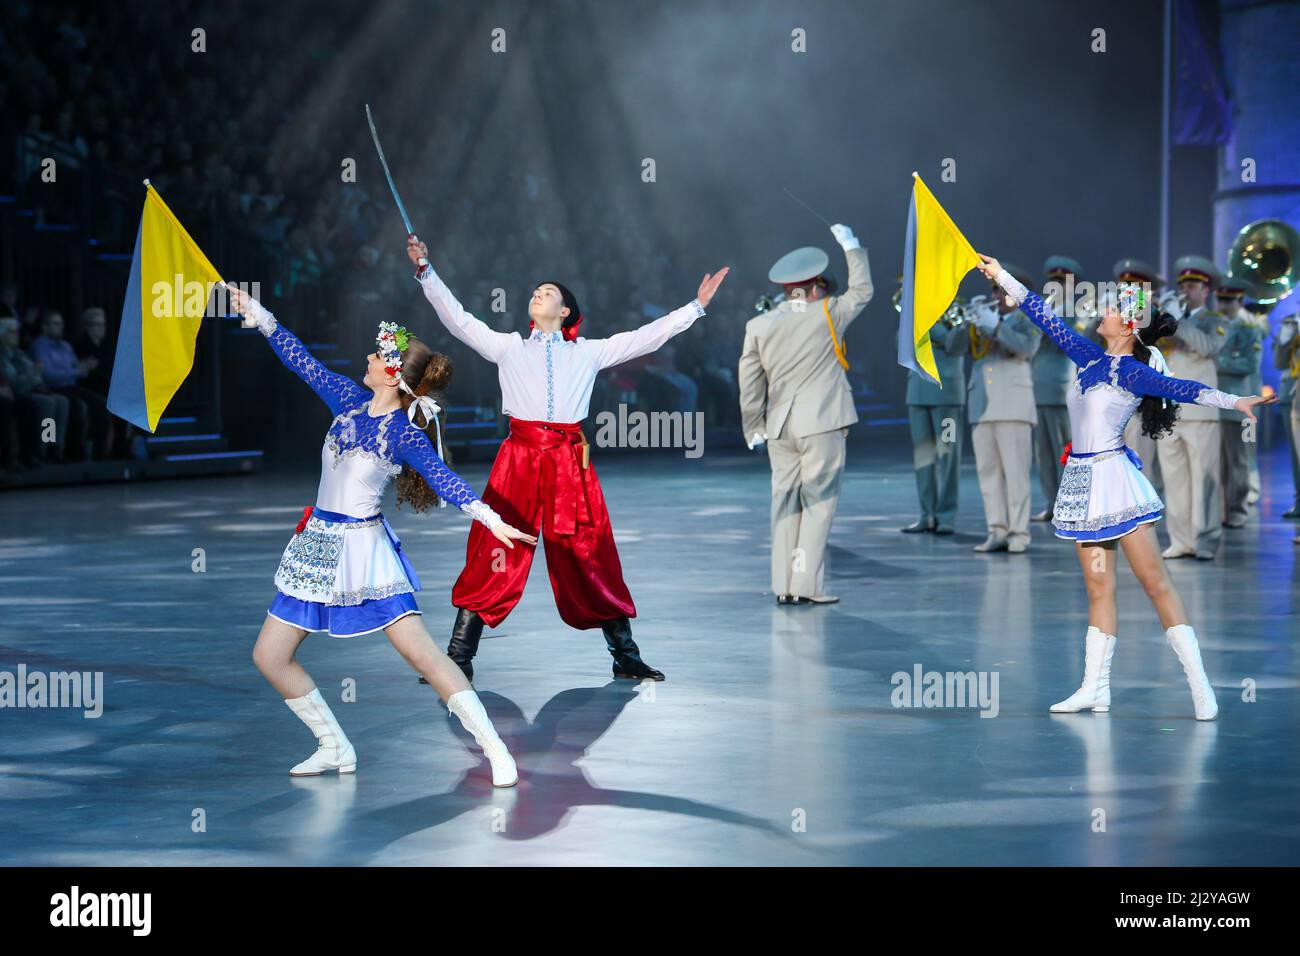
[898,173,980,386]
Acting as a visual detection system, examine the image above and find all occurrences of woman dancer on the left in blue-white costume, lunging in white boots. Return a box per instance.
[228,286,537,787]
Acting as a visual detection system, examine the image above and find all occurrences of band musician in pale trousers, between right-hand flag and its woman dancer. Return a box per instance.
[967,265,1043,553]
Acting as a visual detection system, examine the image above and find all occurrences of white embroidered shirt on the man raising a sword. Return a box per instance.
[417,267,705,423]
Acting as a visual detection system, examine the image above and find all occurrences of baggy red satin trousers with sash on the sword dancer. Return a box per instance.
[451,419,637,630]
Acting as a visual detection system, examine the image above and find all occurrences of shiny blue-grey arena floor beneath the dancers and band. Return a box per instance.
[0,442,1300,866]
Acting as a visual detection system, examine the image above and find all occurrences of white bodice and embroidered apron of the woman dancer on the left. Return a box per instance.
[276,402,415,606]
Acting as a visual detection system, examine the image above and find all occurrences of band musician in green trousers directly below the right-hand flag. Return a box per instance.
[902,306,971,535]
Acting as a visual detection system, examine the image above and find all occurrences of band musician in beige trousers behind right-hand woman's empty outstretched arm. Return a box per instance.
[1157,256,1227,561]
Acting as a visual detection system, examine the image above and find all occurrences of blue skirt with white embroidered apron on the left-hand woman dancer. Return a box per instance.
[267,507,421,637]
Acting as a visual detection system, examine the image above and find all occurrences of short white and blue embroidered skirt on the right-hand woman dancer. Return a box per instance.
[1052,446,1165,541]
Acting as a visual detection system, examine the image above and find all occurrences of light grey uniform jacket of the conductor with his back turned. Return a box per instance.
[740,248,875,442]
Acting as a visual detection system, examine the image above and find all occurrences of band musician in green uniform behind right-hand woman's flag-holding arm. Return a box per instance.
[1031,256,1091,522]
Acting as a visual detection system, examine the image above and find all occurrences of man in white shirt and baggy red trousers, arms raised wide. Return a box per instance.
[407,235,728,680]
